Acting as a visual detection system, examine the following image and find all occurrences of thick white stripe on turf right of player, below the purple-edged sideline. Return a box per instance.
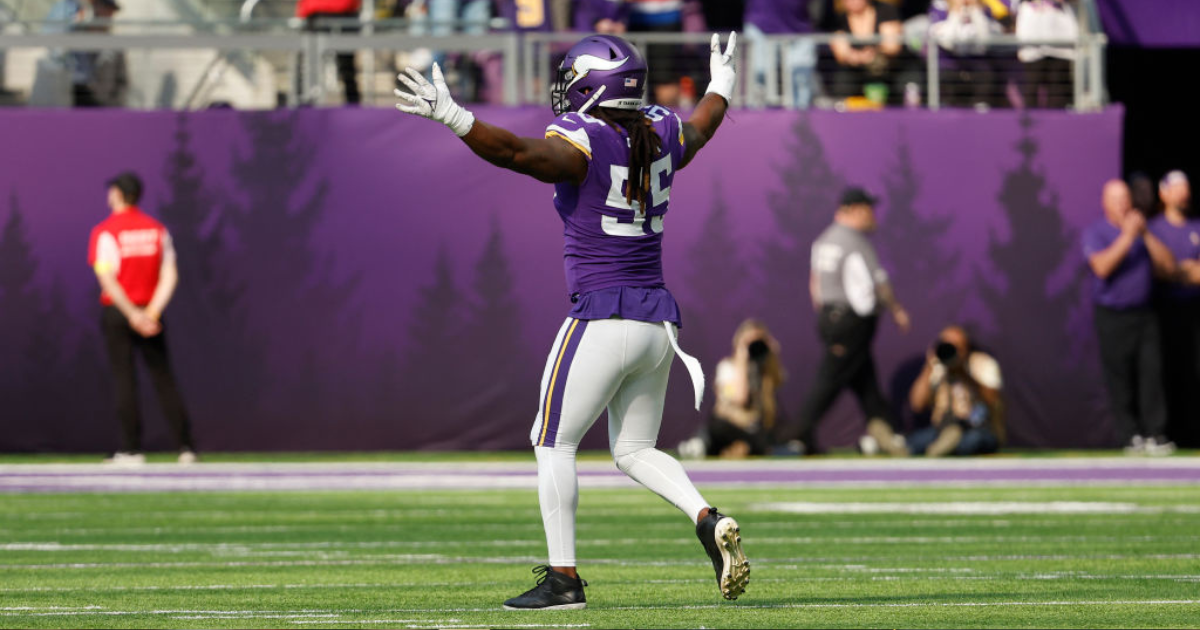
[749,500,1198,516]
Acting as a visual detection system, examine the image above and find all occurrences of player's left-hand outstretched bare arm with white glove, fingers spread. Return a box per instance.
[396,64,588,184]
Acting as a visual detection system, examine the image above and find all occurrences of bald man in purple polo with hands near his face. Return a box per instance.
[1082,180,1176,455]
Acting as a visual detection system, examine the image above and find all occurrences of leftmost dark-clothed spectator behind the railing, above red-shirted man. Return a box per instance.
[43,0,130,107]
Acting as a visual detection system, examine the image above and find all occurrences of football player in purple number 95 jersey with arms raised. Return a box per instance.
[396,34,750,610]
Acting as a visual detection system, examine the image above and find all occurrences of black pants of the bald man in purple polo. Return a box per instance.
[1096,306,1166,443]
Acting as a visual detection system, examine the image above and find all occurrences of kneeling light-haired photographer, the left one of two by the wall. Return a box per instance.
[679,319,784,458]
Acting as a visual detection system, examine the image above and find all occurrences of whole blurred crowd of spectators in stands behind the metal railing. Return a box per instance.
[14,0,1079,108]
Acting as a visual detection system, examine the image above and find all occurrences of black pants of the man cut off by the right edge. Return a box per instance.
[1158,300,1200,446]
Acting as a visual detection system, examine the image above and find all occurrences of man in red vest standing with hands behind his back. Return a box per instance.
[88,173,196,466]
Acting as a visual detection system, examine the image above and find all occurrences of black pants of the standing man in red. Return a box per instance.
[101,306,193,452]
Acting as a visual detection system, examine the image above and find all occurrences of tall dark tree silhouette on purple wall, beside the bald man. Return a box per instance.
[980,116,1103,445]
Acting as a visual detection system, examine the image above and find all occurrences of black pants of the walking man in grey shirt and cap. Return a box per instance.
[799,306,892,452]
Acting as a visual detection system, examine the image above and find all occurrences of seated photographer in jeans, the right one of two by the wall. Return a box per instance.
[907,325,1004,457]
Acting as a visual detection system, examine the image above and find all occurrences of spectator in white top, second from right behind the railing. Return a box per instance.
[929,0,1009,107]
